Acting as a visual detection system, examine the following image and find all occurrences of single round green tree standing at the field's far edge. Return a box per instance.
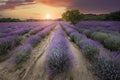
[62,10,83,24]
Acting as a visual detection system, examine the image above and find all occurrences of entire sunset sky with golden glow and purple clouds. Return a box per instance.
[0,0,120,19]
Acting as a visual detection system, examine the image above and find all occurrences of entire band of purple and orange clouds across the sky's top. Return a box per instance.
[0,0,120,13]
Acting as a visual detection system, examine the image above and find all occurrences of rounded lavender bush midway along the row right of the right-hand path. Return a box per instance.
[79,39,100,60]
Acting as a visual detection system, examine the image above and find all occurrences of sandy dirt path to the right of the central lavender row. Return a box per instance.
[66,37,98,80]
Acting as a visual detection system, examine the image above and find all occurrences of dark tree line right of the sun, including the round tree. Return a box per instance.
[62,10,120,24]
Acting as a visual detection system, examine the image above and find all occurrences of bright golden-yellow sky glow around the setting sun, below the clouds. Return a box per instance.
[0,3,66,20]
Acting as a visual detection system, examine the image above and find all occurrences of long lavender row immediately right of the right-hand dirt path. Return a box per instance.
[63,24,120,80]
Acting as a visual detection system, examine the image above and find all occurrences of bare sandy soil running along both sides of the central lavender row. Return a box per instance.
[0,25,97,80]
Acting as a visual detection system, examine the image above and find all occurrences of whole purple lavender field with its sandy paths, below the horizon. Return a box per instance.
[0,21,120,80]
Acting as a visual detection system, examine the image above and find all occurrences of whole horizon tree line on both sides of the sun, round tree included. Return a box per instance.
[0,10,120,24]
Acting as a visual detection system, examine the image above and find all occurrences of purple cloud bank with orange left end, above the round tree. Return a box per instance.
[36,0,120,13]
